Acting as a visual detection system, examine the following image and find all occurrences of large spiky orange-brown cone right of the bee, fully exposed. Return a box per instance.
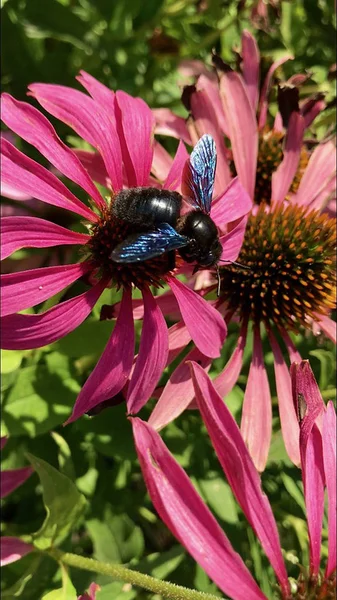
[220,205,336,331]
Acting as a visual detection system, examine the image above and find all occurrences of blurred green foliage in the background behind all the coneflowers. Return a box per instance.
[1,0,336,600]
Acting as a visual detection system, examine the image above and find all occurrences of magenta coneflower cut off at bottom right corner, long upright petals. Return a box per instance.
[131,361,336,600]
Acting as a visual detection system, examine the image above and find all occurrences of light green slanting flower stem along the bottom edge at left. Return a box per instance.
[47,548,219,600]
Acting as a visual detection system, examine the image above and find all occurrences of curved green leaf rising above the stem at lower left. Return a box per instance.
[27,453,86,550]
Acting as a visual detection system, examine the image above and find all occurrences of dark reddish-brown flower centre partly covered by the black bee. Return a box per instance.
[84,199,175,289]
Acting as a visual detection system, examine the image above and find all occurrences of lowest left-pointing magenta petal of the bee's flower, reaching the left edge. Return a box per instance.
[1,281,106,350]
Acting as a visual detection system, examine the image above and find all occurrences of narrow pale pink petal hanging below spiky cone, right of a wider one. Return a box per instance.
[268,331,301,466]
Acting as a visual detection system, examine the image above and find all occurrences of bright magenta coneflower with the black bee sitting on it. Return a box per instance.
[1,72,251,421]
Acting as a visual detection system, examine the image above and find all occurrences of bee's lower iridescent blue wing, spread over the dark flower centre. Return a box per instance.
[110,223,189,263]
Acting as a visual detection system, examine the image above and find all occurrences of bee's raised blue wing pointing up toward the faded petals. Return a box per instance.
[182,134,216,215]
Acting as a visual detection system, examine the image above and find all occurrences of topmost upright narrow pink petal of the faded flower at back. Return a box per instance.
[241,30,260,112]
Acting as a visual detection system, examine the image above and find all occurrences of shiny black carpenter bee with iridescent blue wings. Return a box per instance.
[110,135,222,284]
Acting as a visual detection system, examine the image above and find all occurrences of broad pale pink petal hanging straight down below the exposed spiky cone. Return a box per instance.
[241,327,272,471]
